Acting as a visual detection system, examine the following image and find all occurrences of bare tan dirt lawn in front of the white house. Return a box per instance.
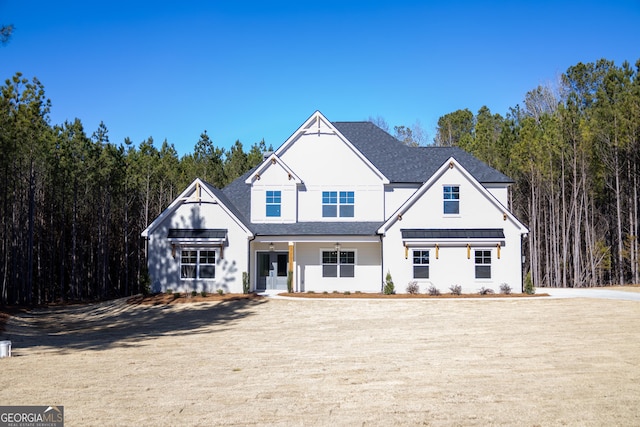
[0,297,640,426]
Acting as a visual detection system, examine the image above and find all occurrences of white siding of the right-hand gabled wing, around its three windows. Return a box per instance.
[383,159,525,293]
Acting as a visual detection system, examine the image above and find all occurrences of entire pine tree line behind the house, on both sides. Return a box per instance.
[0,59,640,305]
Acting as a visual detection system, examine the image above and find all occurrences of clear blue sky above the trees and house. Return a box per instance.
[0,0,640,155]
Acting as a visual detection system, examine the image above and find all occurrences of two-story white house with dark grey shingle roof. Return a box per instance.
[142,112,528,293]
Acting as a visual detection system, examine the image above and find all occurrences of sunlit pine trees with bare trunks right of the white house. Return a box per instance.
[434,59,640,287]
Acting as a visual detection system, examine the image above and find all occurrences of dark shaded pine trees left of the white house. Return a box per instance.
[0,73,272,305]
